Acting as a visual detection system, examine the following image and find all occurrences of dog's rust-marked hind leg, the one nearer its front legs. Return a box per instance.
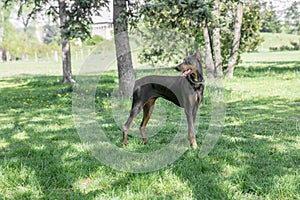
[140,97,156,144]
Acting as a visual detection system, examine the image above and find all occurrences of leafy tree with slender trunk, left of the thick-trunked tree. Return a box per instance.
[5,0,109,82]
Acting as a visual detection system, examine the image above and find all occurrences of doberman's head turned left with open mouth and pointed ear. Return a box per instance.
[175,51,204,83]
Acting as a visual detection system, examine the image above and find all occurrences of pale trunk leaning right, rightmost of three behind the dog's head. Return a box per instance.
[226,4,243,78]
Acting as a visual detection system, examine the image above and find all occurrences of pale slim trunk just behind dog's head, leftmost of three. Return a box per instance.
[203,22,215,79]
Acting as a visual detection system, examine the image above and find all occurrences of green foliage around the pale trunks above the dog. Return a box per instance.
[135,0,263,66]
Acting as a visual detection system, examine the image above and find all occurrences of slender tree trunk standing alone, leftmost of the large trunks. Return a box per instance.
[59,0,75,83]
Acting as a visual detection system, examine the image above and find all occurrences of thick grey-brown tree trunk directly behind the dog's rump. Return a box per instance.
[113,0,135,97]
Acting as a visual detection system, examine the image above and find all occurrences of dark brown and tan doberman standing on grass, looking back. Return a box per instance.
[123,51,204,149]
